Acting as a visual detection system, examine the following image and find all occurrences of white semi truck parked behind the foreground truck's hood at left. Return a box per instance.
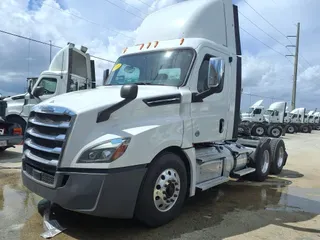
[4,43,95,132]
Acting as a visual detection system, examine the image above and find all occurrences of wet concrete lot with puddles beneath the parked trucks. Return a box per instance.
[0,131,320,240]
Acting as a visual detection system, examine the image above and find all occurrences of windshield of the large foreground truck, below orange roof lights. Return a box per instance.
[106,49,194,86]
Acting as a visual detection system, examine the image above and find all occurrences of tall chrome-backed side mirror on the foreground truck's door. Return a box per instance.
[208,57,225,88]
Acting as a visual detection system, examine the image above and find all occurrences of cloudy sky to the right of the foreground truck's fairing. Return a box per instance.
[238,0,320,108]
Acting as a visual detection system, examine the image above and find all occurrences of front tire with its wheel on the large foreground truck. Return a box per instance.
[135,152,188,227]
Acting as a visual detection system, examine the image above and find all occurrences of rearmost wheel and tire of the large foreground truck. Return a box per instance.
[270,139,287,175]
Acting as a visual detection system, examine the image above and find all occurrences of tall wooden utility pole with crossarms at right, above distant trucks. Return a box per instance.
[286,22,300,110]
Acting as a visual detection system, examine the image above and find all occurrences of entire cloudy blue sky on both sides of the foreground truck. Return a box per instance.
[0,0,320,108]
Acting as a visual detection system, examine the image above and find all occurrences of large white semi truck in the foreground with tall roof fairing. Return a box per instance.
[22,0,288,227]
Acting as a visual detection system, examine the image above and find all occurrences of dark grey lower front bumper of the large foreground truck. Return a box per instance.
[22,163,147,218]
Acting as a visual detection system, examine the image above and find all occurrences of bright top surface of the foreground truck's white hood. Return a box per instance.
[38,85,180,113]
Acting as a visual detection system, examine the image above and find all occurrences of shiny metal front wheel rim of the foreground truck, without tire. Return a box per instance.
[153,168,180,212]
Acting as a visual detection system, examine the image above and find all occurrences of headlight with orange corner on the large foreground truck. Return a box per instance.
[78,138,130,163]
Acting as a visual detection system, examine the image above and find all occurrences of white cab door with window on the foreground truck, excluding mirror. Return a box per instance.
[191,47,233,143]
